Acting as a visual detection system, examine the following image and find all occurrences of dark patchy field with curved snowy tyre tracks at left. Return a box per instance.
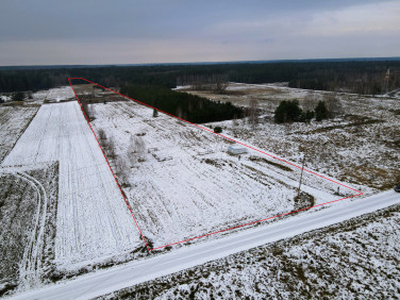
[0,163,58,295]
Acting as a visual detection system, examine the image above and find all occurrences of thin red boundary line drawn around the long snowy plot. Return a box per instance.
[68,77,363,252]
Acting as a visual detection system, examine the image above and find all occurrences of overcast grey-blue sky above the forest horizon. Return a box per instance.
[0,0,400,66]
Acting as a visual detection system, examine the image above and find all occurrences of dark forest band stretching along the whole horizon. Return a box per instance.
[0,59,400,94]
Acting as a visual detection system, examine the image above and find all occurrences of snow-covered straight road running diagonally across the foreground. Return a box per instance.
[10,191,400,299]
